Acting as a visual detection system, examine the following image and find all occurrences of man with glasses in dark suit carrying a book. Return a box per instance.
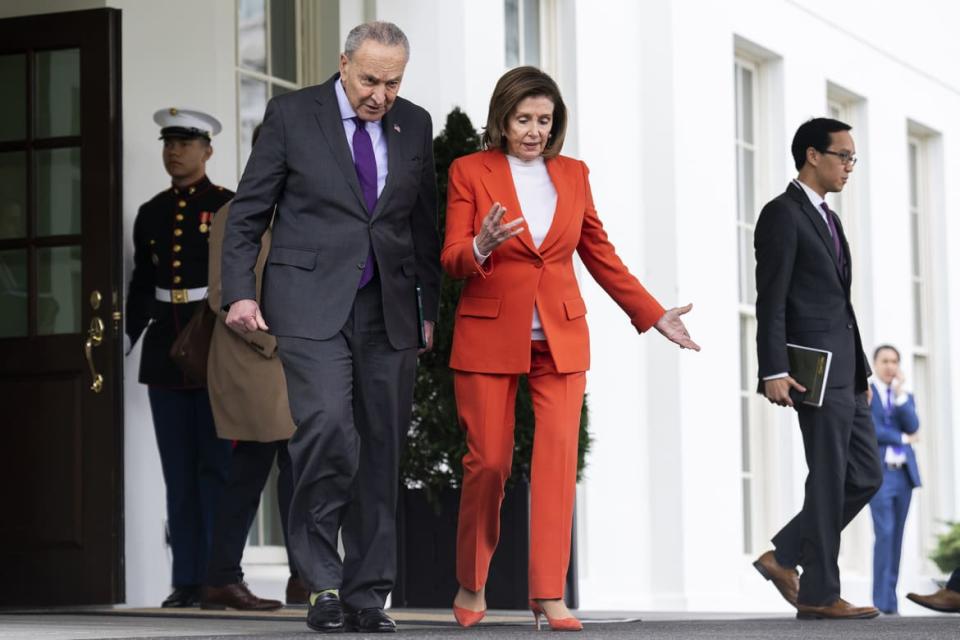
[754,118,883,618]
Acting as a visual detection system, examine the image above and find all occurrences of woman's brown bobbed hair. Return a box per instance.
[482,67,567,158]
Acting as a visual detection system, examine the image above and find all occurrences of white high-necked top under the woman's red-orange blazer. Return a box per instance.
[473,155,557,340]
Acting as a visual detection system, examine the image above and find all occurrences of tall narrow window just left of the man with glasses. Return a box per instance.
[733,58,762,553]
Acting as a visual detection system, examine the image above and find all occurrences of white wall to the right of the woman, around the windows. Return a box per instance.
[564,0,960,610]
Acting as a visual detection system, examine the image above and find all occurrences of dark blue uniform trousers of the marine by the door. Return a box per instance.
[147,386,230,587]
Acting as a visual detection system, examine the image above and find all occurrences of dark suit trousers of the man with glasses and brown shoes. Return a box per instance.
[773,386,883,606]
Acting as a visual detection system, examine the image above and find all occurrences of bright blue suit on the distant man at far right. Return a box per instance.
[870,384,920,613]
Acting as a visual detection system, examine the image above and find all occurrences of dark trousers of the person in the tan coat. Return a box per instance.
[204,440,297,587]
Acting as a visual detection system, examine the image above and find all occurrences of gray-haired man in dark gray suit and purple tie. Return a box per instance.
[223,22,440,632]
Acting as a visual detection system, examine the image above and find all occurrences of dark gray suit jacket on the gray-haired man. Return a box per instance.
[222,74,440,349]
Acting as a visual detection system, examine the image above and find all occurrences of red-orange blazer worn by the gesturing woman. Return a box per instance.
[440,150,664,373]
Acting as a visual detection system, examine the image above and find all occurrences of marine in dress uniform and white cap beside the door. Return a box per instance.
[126,108,233,607]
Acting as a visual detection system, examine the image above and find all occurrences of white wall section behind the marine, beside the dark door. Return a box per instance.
[107,0,237,606]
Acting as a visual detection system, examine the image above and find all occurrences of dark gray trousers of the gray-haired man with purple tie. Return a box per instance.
[277,276,417,609]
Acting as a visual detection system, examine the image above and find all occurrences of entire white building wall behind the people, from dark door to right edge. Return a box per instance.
[7,0,960,613]
